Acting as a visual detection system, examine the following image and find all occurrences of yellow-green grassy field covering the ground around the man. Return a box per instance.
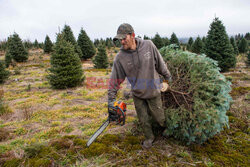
[0,50,250,167]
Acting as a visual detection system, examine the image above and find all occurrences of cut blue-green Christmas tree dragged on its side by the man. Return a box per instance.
[160,47,231,144]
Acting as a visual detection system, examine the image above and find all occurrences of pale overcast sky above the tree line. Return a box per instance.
[0,0,250,42]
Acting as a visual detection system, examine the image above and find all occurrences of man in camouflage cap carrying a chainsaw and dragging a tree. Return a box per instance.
[108,23,171,148]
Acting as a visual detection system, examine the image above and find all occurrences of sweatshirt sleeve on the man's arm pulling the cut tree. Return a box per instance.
[152,42,172,81]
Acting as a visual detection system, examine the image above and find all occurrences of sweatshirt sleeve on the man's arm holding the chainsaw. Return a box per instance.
[108,55,126,102]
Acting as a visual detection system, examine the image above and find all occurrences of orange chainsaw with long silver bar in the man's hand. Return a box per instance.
[87,101,127,147]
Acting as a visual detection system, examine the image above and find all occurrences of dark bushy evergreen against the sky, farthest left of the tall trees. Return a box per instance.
[8,33,28,62]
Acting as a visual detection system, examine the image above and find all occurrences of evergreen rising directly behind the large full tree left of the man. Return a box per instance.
[62,25,83,58]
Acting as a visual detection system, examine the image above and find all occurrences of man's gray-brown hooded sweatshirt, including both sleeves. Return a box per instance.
[108,38,171,102]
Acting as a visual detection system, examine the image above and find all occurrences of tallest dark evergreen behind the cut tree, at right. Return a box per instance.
[205,17,236,71]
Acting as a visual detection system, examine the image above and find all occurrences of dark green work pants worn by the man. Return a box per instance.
[133,95,166,139]
